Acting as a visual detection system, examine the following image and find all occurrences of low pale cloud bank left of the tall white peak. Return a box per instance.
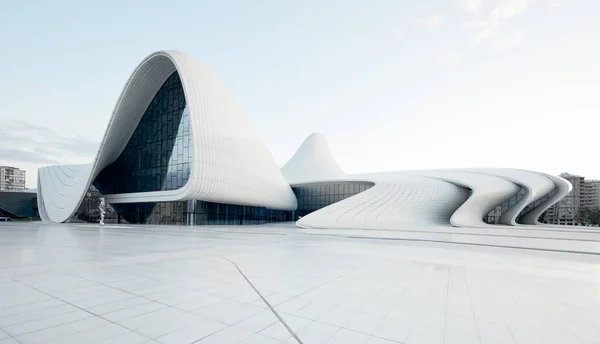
[0,121,99,165]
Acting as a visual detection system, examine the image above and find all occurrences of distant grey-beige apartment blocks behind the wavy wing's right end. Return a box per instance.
[545,173,600,226]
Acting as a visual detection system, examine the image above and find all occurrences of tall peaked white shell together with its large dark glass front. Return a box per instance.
[38,51,296,222]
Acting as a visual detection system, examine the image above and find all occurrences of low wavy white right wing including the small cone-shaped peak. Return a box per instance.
[283,134,571,230]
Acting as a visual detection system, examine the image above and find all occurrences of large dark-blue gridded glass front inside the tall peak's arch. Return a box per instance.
[94,72,192,195]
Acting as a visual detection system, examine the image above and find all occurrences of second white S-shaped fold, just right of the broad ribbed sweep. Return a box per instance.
[410,170,521,227]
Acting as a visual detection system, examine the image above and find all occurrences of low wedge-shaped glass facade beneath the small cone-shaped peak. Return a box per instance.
[292,182,374,218]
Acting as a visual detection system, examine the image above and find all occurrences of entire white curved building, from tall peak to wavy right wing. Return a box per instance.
[38,51,571,230]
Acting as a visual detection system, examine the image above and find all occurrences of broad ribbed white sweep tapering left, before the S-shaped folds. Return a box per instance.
[297,173,468,230]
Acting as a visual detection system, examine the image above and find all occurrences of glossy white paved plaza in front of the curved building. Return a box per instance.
[0,222,600,344]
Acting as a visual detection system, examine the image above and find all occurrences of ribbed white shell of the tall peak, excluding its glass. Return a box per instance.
[38,51,296,222]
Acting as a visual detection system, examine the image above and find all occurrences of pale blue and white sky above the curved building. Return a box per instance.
[0,0,600,188]
